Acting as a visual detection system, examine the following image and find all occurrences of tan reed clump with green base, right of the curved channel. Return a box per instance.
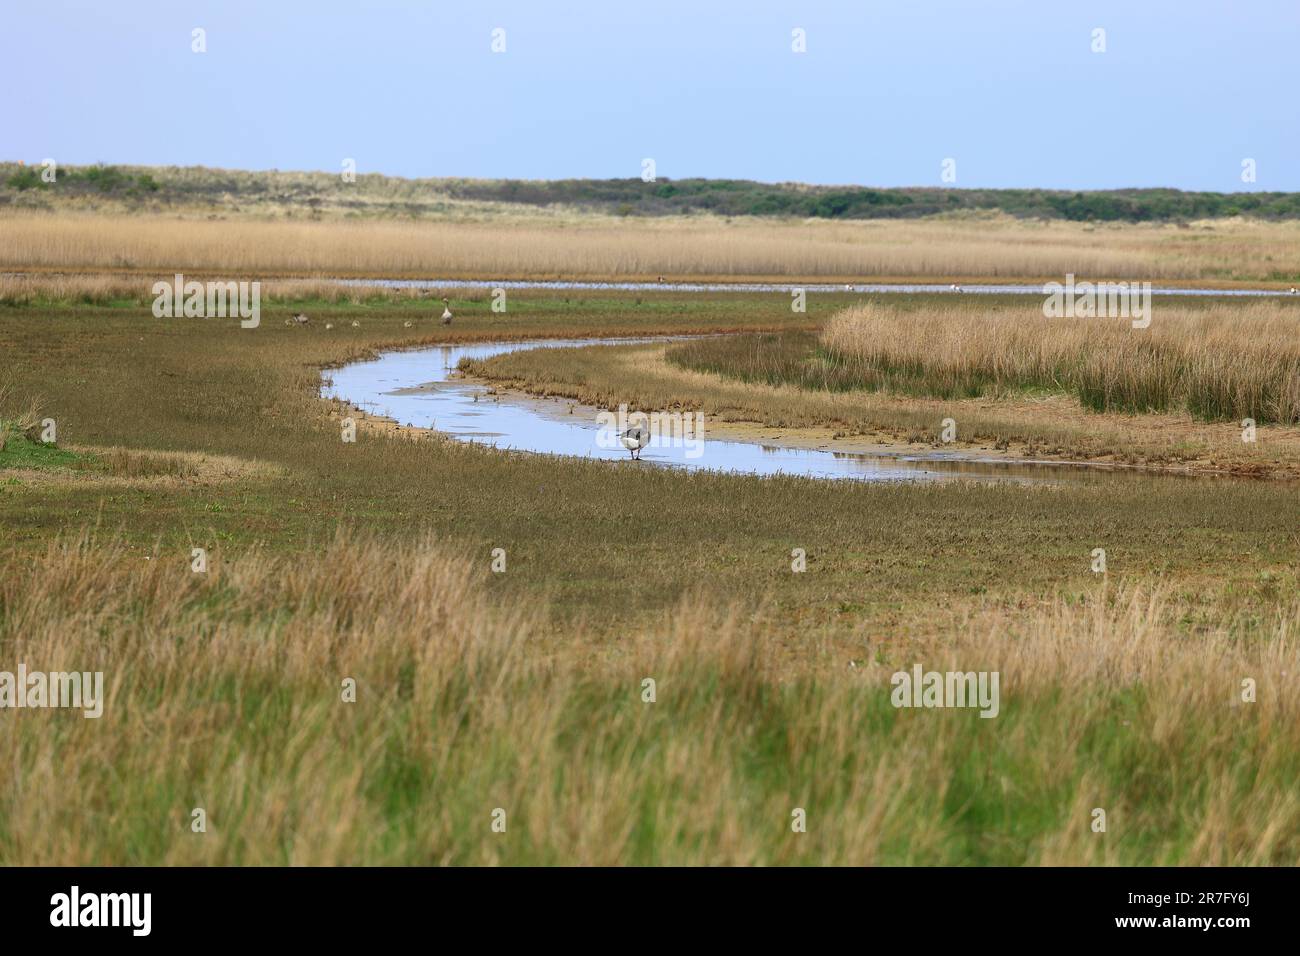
[822,300,1300,424]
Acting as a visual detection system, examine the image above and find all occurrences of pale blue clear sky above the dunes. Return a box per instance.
[0,0,1300,191]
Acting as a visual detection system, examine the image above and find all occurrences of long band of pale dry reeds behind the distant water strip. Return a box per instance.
[0,213,1300,281]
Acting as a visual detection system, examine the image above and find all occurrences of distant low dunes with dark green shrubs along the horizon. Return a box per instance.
[10,163,1300,222]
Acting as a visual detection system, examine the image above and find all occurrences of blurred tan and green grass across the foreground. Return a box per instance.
[0,533,1300,865]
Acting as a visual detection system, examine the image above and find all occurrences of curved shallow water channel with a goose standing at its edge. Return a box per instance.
[321,338,1190,481]
